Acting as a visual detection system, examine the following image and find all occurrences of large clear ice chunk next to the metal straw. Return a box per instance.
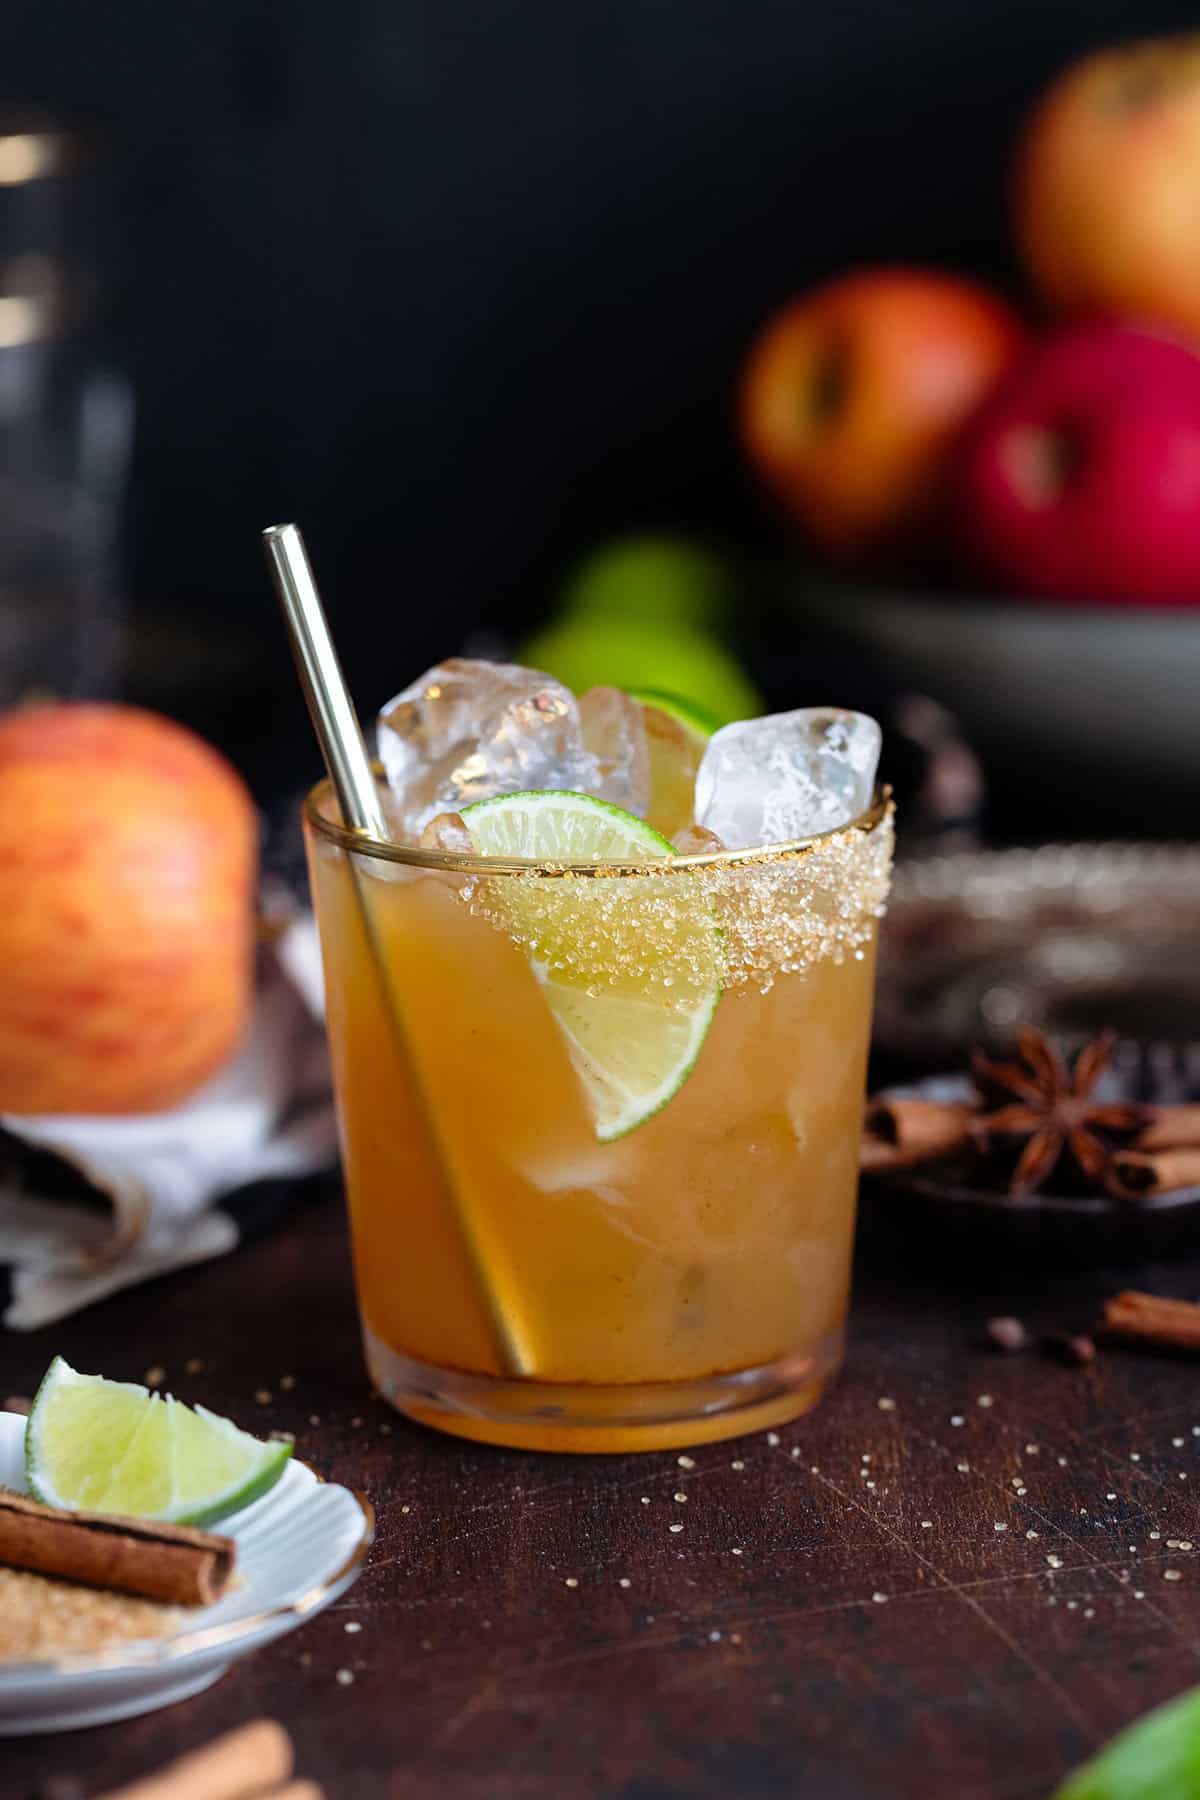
[378,657,596,841]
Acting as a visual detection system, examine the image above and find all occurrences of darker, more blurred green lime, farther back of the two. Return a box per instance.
[560,535,736,626]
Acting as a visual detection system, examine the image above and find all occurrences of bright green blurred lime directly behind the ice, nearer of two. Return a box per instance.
[518,612,763,725]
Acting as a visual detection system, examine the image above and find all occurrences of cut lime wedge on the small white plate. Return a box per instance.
[25,1355,291,1525]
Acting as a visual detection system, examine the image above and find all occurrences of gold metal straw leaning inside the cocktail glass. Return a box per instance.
[271,526,534,1375]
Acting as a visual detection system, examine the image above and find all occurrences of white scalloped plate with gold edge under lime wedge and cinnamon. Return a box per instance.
[0,1413,374,1737]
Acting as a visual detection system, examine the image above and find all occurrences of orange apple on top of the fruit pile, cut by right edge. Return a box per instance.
[1013,32,1200,337]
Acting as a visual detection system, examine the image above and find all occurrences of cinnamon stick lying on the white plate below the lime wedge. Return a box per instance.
[0,1490,236,1606]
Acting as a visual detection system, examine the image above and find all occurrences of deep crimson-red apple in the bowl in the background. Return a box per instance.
[950,320,1200,605]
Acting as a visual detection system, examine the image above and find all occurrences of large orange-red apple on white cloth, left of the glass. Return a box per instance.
[0,704,257,1112]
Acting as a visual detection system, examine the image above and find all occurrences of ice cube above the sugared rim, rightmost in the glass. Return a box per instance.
[696,706,880,850]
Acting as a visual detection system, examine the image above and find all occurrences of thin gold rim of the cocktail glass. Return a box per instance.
[304,779,892,878]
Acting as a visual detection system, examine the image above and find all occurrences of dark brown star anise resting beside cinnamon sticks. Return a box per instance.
[972,1030,1146,1193]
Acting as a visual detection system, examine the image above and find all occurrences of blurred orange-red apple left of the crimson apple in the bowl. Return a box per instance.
[739,268,1024,556]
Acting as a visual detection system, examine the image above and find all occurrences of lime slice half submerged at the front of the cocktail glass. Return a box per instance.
[462,792,721,1143]
